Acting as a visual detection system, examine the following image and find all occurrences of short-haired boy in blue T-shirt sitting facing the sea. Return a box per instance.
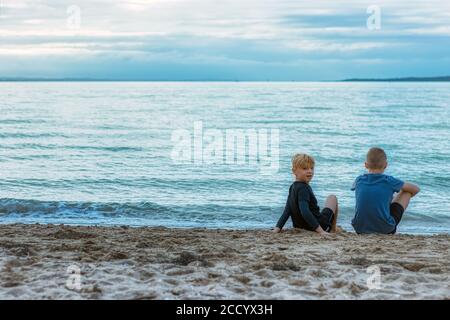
[352,148,420,234]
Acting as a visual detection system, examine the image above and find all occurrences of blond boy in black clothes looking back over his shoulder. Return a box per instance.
[273,154,338,234]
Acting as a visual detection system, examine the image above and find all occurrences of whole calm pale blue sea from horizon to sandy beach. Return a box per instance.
[0,82,450,233]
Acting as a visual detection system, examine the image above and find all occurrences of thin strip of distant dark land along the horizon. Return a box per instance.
[0,76,450,82]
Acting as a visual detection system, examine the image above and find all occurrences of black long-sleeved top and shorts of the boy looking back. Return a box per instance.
[277,181,333,231]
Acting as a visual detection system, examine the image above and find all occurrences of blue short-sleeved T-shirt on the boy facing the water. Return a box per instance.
[352,173,404,234]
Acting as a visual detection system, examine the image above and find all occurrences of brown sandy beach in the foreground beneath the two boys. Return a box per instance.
[0,225,450,299]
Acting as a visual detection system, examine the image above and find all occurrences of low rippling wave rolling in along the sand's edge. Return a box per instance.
[0,198,450,234]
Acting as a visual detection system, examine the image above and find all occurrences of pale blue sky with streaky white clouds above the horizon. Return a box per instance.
[0,0,450,81]
